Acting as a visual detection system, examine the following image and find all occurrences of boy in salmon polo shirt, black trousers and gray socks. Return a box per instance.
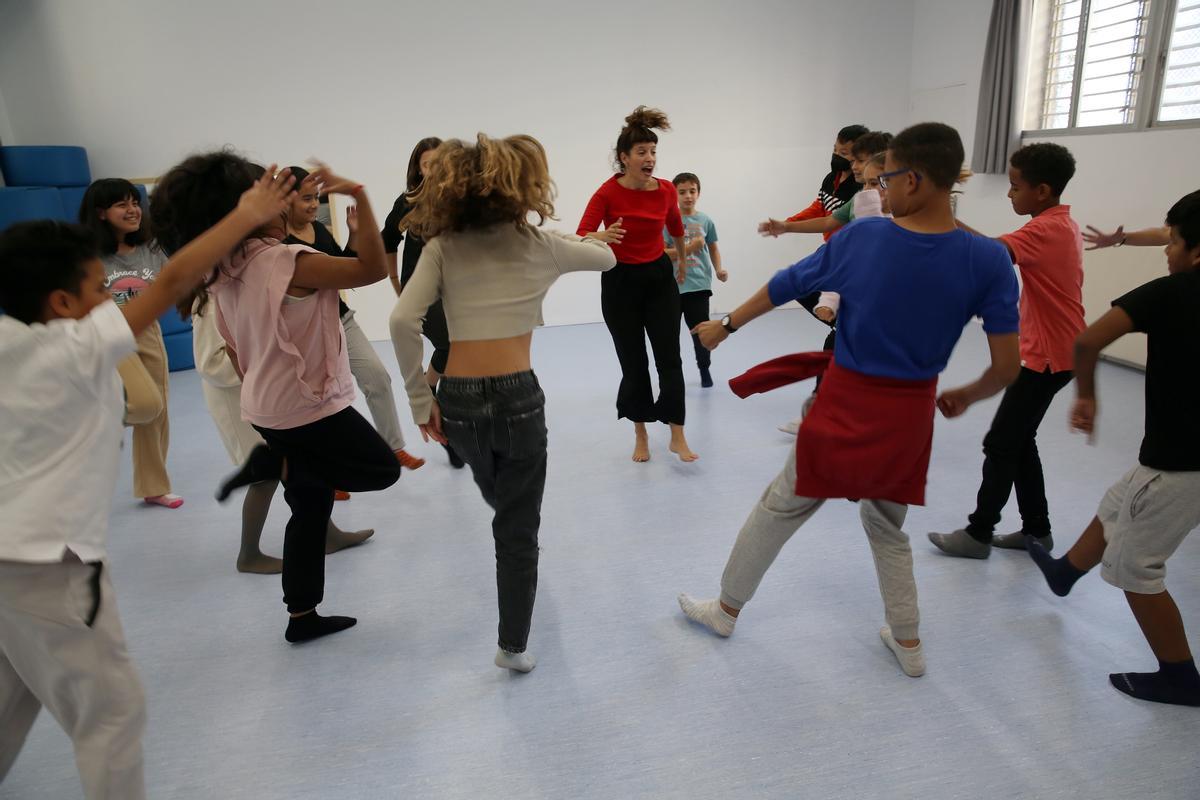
[929,144,1086,559]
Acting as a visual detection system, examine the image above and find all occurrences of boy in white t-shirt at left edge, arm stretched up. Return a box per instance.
[0,167,294,800]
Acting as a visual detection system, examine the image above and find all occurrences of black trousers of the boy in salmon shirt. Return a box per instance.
[967,367,1072,542]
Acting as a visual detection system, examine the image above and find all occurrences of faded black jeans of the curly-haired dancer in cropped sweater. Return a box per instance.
[438,372,547,652]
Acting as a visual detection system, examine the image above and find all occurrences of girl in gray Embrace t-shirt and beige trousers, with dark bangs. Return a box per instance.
[79,178,184,509]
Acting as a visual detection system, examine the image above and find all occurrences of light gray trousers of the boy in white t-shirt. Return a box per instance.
[0,558,145,800]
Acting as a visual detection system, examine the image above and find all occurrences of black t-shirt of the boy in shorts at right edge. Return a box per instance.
[1112,271,1200,471]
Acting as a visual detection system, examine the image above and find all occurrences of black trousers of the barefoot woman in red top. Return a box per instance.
[600,253,684,425]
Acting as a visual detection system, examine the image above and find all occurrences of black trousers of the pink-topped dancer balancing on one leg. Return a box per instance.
[254,408,400,613]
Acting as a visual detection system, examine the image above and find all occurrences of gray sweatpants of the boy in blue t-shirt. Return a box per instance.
[721,447,920,639]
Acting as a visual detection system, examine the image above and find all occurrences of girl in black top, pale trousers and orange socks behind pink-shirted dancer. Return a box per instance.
[283,167,425,489]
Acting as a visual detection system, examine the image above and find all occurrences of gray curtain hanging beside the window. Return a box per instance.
[971,0,1024,174]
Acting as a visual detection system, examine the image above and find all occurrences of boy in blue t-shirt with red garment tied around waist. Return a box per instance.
[679,122,1019,678]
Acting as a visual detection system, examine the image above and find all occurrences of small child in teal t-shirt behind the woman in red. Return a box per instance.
[662,173,730,389]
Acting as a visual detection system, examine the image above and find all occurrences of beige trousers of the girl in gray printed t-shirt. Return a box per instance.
[116,323,170,498]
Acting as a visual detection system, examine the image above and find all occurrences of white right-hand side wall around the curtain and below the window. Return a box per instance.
[910,0,1200,365]
